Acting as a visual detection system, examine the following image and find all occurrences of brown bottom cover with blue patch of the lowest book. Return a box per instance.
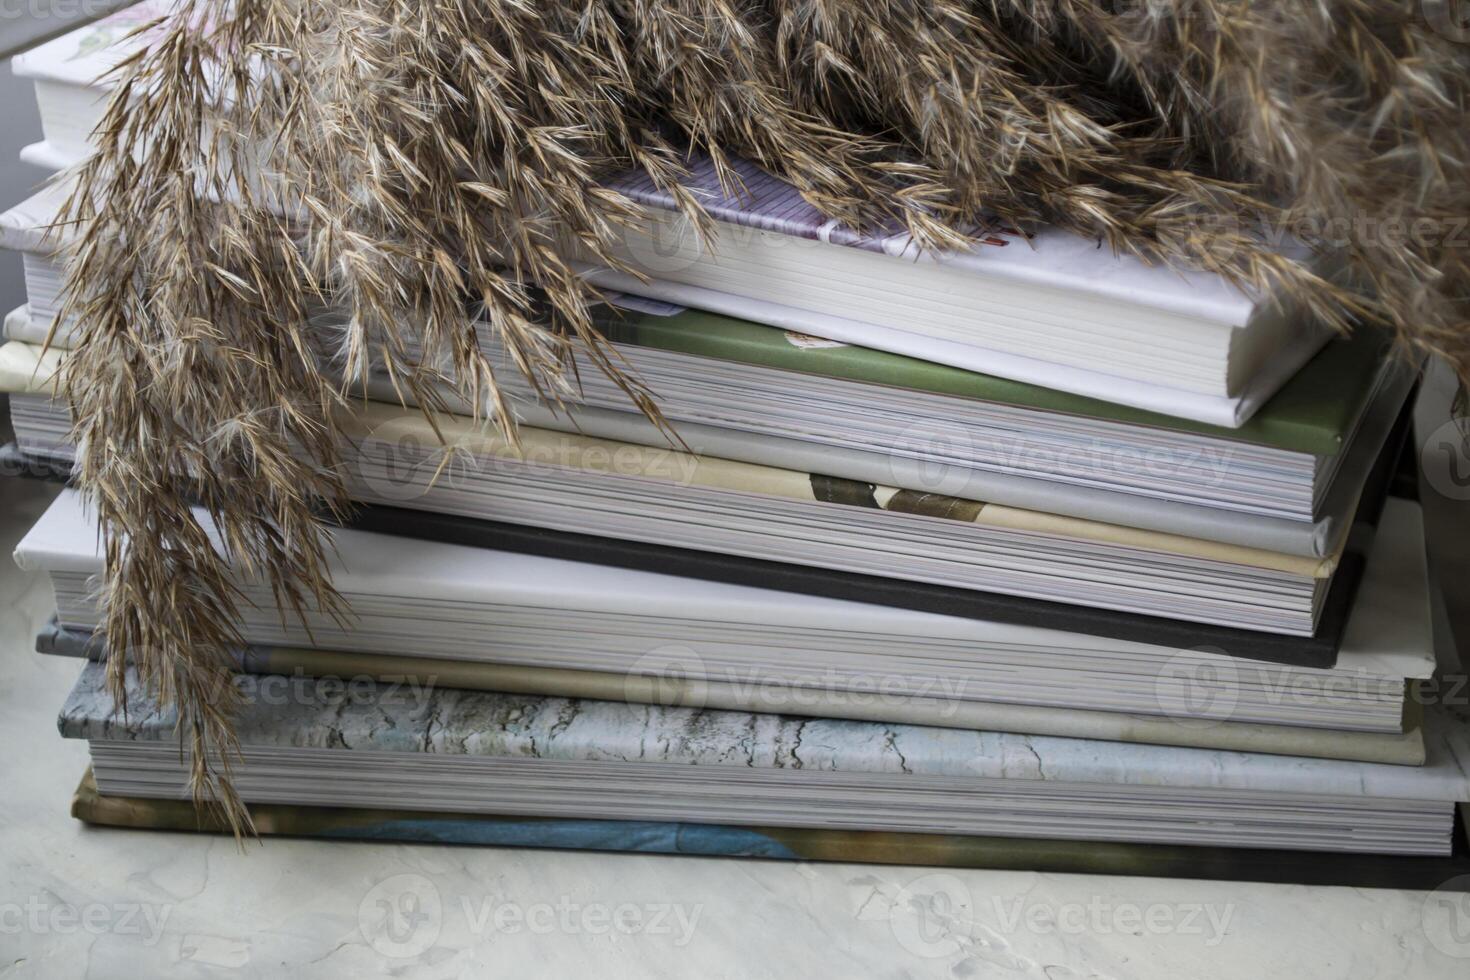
[71,770,1470,892]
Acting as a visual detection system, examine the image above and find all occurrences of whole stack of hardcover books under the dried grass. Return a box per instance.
[0,15,1470,883]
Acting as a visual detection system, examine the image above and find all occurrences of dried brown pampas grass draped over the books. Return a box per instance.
[54,0,1470,830]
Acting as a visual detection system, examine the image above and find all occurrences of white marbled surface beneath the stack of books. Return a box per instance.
[0,479,1470,980]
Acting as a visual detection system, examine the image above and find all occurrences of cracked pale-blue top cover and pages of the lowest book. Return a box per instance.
[59,663,1470,857]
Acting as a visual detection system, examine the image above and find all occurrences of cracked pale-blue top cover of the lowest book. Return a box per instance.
[57,663,1470,805]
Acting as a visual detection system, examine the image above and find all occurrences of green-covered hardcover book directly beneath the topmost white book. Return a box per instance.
[490,310,1417,555]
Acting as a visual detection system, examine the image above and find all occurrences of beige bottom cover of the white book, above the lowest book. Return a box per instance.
[35,620,1424,765]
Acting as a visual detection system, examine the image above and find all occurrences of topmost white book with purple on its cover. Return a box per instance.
[584,156,1327,426]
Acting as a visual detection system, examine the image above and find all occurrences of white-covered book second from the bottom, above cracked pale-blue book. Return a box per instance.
[15,491,1435,731]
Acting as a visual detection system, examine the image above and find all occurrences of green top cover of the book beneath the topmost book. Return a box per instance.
[601,310,1389,455]
